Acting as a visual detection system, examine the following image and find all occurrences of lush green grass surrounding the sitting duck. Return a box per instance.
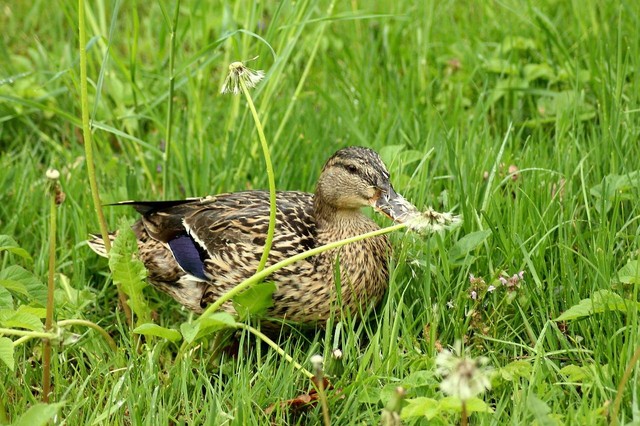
[0,0,640,425]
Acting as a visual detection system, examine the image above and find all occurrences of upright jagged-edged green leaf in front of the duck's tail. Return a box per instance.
[109,221,151,324]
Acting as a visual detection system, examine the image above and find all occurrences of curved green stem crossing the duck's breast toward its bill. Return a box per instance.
[202,223,407,316]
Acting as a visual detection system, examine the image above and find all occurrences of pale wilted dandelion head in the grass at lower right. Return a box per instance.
[436,341,491,401]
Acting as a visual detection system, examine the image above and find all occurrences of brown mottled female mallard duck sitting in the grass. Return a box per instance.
[89,147,420,323]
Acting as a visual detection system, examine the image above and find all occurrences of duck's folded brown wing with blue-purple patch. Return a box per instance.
[136,191,315,281]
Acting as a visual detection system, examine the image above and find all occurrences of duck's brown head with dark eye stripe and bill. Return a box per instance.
[316,146,415,220]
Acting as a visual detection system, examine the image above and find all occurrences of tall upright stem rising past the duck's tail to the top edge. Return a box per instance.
[78,0,133,325]
